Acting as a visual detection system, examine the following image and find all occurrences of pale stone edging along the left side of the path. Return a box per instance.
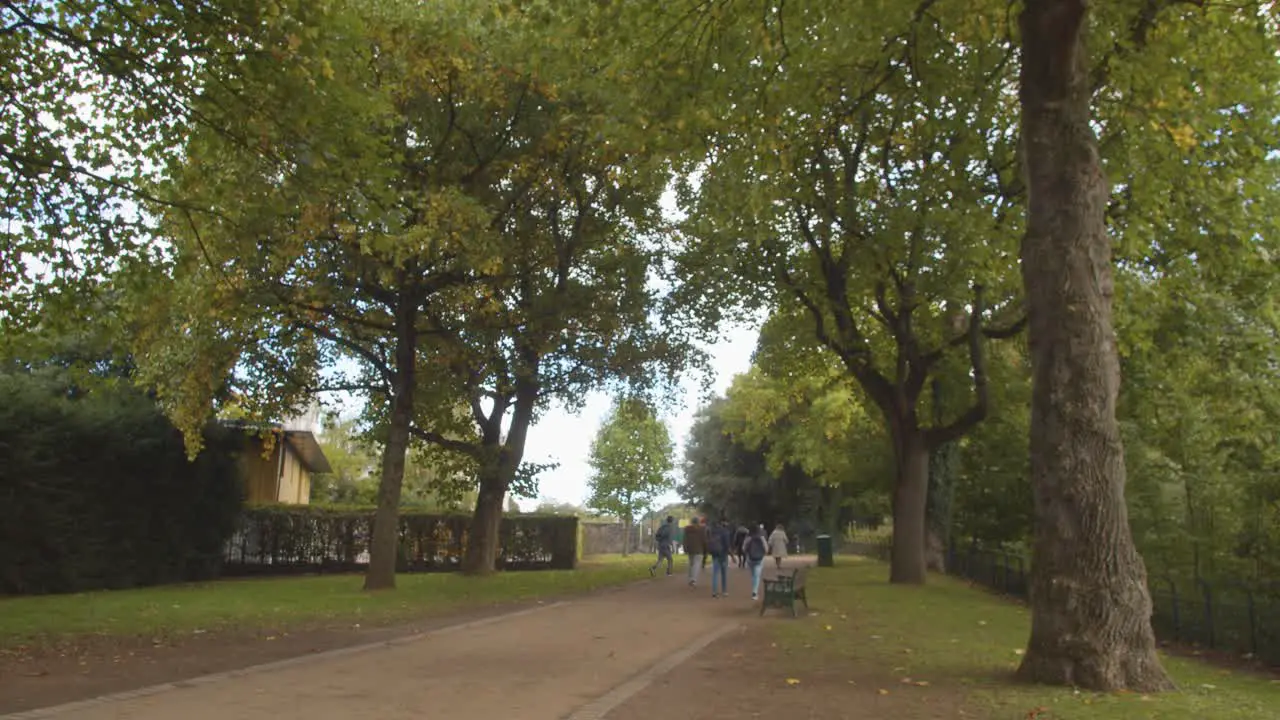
[0,600,573,720]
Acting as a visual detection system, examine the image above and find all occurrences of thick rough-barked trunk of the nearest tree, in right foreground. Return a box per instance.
[1019,0,1171,691]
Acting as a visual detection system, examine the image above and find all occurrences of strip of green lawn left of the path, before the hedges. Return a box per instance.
[0,555,653,650]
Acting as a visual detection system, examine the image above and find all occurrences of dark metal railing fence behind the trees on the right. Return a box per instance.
[842,539,1280,666]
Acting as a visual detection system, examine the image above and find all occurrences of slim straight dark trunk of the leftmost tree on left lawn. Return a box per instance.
[365,292,417,591]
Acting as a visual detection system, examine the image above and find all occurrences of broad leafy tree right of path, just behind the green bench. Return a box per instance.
[681,4,1021,583]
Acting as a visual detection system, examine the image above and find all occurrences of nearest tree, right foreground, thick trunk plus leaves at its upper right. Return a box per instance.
[1019,0,1276,691]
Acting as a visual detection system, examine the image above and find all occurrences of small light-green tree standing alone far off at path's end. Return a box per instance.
[586,397,673,555]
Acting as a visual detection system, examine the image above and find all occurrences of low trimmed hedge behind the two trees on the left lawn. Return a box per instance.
[223,505,579,575]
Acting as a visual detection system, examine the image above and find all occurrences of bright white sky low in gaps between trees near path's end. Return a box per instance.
[517,319,759,510]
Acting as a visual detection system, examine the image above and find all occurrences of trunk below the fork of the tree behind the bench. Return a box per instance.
[888,429,929,585]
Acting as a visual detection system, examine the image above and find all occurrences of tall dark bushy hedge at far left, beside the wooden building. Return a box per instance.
[0,373,241,594]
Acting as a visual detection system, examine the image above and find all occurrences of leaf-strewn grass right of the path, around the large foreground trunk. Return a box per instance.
[772,556,1280,720]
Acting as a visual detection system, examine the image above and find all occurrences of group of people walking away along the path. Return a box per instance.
[649,515,788,600]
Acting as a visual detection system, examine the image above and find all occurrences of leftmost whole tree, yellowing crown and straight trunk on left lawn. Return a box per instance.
[129,3,593,589]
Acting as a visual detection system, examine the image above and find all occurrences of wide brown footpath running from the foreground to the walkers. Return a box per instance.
[0,559,808,720]
